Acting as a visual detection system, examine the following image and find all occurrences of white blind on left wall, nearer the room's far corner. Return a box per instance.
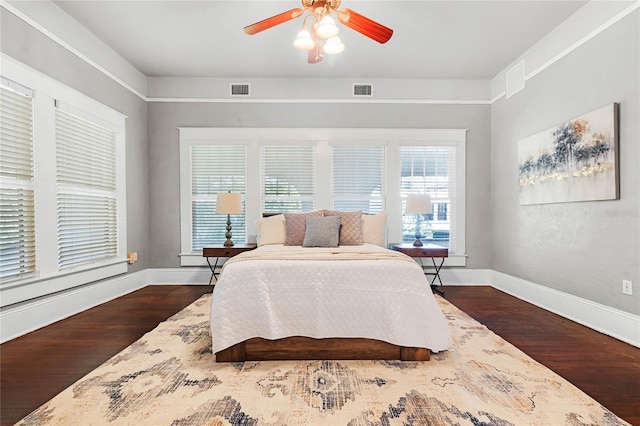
[55,108,118,269]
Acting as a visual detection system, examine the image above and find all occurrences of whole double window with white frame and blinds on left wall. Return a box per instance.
[0,56,127,306]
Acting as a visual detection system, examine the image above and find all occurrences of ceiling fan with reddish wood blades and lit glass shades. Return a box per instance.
[244,0,393,64]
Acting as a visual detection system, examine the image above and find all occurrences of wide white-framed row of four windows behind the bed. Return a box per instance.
[180,128,466,266]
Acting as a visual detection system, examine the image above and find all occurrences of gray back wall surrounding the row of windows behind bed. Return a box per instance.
[149,103,491,268]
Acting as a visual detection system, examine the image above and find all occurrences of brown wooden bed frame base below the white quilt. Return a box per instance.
[216,336,431,362]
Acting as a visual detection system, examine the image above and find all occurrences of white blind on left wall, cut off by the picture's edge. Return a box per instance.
[0,84,36,280]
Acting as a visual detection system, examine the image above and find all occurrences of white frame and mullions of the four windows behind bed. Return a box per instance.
[178,127,467,266]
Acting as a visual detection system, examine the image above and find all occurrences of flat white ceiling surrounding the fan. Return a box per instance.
[55,0,586,80]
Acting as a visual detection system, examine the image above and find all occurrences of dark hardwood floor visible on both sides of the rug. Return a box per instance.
[0,285,640,425]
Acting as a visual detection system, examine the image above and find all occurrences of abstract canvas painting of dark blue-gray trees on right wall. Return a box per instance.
[518,103,620,205]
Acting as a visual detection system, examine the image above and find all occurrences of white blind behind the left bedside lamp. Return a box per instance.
[190,145,247,249]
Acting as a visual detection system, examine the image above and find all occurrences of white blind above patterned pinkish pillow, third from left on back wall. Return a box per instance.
[331,145,386,214]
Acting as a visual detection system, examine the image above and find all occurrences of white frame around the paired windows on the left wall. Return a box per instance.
[0,54,128,306]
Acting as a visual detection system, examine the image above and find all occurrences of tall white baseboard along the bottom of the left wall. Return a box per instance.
[0,270,149,343]
